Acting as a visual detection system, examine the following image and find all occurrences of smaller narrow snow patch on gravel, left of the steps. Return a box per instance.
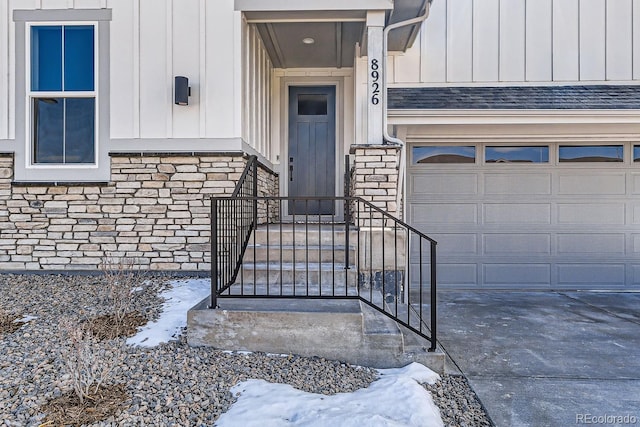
[127,279,211,347]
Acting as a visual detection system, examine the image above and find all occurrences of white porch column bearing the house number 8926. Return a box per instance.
[367,11,386,144]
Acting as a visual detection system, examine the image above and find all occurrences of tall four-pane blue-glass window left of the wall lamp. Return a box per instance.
[27,24,97,165]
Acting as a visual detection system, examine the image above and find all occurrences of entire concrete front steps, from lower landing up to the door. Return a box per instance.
[187,224,444,372]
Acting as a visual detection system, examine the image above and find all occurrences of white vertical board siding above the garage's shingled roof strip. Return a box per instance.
[388,0,640,85]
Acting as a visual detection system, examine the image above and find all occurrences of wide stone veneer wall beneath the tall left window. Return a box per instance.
[0,153,278,271]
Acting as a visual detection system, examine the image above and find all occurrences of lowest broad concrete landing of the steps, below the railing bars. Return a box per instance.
[187,298,444,372]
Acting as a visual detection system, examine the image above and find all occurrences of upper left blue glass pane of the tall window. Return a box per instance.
[31,27,62,91]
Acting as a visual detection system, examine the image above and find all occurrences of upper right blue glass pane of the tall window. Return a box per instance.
[64,26,94,91]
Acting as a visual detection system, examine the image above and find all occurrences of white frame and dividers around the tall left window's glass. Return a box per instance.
[25,21,100,169]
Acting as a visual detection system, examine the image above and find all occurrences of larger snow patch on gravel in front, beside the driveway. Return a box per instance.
[216,363,443,427]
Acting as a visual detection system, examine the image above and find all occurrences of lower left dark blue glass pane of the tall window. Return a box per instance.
[33,98,64,163]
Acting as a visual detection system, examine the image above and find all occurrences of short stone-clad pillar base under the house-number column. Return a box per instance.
[351,145,402,219]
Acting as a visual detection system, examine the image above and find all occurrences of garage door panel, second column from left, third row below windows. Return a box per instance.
[484,233,551,256]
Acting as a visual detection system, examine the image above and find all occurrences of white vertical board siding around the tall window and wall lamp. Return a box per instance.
[0,0,272,155]
